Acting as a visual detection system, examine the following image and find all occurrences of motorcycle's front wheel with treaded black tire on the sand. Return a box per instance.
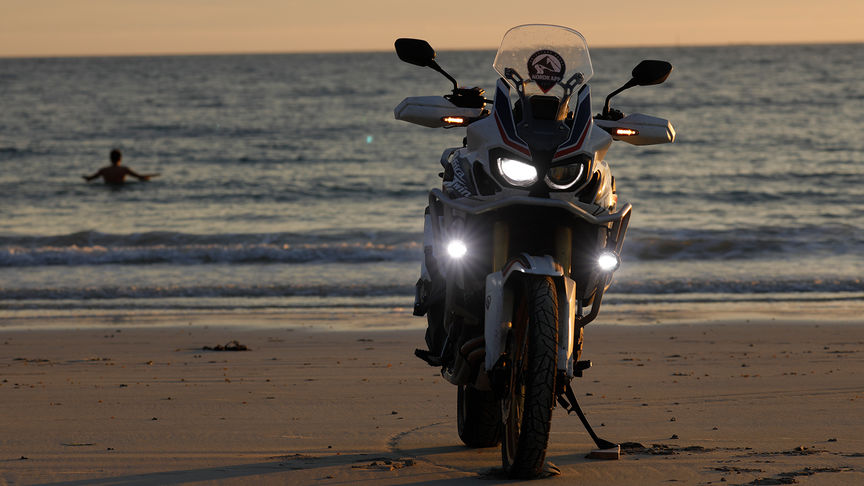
[501,277,558,478]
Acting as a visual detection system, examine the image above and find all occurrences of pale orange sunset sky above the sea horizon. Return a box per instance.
[0,0,864,57]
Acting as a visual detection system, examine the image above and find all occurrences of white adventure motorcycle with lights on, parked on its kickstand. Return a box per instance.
[394,25,675,478]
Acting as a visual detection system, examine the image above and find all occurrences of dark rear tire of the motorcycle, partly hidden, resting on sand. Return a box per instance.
[456,385,503,448]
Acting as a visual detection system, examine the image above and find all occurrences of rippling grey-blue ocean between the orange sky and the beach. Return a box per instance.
[0,39,864,322]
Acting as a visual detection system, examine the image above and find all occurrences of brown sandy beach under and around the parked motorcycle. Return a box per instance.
[0,306,864,485]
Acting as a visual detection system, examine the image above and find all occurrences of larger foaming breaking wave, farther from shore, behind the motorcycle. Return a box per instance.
[0,226,864,268]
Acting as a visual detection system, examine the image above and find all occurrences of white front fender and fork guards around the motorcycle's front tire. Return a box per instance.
[483,253,576,378]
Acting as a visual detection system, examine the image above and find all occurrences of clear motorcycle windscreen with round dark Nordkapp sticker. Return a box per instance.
[492,24,594,99]
